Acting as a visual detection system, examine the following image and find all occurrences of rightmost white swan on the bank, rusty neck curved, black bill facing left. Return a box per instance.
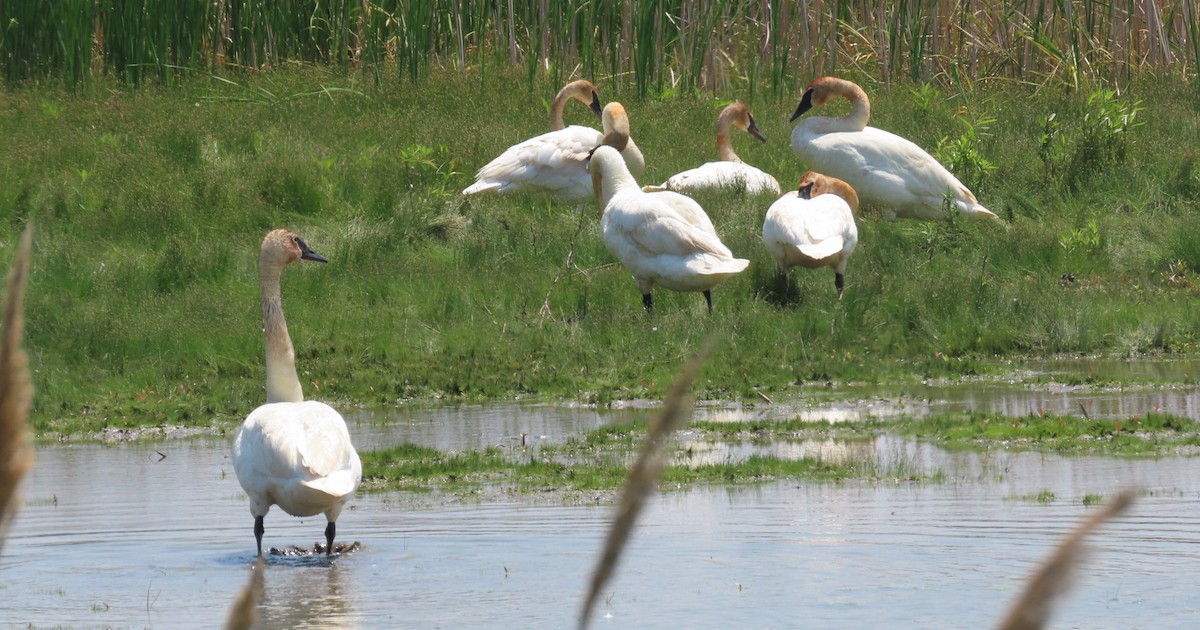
[792,77,996,218]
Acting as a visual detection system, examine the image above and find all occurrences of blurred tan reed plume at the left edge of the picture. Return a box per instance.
[0,227,34,545]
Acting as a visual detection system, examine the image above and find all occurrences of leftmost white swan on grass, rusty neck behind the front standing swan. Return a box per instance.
[462,102,646,199]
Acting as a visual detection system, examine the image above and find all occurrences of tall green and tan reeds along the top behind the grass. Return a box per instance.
[0,0,1200,90]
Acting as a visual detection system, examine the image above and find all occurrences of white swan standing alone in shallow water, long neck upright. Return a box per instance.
[233,229,362,557]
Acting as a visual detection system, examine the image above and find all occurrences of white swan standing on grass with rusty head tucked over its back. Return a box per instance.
[762,170,858,300]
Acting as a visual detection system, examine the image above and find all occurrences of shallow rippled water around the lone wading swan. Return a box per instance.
[0,406,1200,629]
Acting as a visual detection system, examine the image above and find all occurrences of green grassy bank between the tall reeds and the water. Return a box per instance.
[0,66,1200,431]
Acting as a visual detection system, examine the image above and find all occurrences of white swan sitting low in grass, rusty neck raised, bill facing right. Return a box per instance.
[642,102,780,194]
